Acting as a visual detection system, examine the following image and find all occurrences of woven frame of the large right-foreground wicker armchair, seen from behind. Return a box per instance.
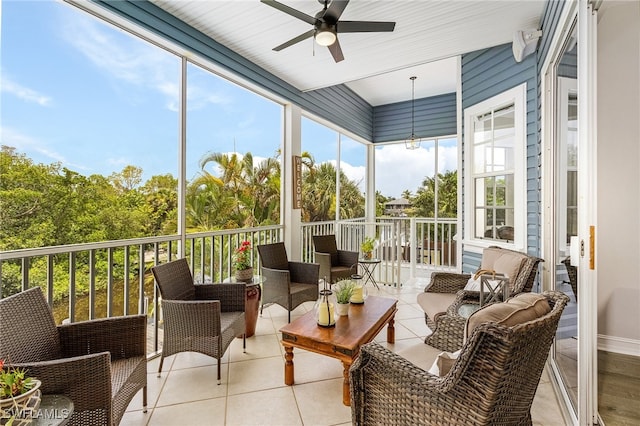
[349,292,569,425]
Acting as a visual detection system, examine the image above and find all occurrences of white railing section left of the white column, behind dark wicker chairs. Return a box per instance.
[0,226,282,354]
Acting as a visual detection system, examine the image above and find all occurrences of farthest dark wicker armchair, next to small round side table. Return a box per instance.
[313,235,358,283]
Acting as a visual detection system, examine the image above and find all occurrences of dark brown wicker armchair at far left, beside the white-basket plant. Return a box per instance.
[0,287,147,425]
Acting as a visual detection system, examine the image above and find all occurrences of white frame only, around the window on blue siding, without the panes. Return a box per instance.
[463,83,527,252]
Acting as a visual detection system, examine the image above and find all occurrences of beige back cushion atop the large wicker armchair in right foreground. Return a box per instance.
[465,293,551,340]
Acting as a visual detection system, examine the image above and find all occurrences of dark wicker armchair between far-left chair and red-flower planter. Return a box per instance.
[151,259,246,384]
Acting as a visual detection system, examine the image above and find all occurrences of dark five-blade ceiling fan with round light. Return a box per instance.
[260,0,396,62]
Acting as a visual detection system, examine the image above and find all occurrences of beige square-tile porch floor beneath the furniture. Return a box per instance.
[121,283,565,426]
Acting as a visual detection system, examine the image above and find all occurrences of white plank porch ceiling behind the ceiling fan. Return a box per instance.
[151,0,545,106]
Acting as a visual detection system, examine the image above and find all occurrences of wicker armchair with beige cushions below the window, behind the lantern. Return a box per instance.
[418,247,543,352]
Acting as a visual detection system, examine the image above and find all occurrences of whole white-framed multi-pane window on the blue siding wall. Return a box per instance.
[465,85,526,247]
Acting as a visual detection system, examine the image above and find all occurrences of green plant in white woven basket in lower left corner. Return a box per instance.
[0,360,41,418]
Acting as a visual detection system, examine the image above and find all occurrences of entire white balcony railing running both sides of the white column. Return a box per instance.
[0,218,456,354]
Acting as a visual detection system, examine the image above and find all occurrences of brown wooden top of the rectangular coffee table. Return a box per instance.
[280,296,398,353]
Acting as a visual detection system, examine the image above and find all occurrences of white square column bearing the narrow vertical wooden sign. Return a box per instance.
[280,105,302,261]
